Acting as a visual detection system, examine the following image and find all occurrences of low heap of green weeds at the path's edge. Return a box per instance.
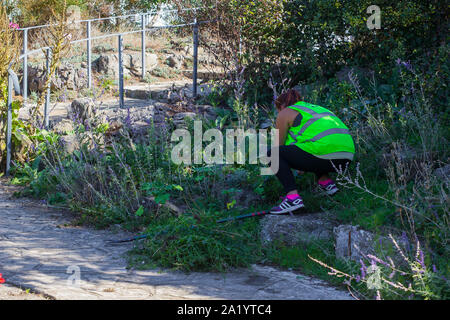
[130,213,261,272]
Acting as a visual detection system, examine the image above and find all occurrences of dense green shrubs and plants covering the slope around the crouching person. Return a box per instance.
[0,0,450,299]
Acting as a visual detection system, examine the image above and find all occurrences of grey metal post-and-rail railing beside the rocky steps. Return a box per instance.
[6,8,211,175]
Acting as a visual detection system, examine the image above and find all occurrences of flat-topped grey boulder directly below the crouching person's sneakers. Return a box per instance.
[261,213,335,246]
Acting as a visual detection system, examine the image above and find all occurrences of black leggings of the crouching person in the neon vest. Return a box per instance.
[269,146,351,193]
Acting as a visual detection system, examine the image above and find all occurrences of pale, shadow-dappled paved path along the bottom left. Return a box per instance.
[0,181,351,300]
